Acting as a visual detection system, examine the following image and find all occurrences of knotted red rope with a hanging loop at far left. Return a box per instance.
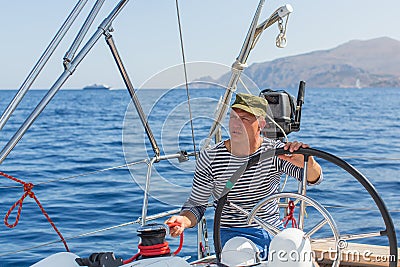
[0,172,69,252]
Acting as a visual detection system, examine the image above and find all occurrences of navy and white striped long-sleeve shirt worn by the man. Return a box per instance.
[182,138,322,227]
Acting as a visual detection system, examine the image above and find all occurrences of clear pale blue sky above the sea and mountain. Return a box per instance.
[0,0,400,89]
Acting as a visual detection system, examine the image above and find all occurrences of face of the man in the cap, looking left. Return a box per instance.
[229,108,259,142]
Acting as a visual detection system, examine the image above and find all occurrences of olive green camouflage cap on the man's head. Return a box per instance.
[231,93,268,117]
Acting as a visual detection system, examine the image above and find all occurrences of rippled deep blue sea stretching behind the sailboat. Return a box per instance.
[0,88,400,266]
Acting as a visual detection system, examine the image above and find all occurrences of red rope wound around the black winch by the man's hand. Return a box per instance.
[122,223,183,264]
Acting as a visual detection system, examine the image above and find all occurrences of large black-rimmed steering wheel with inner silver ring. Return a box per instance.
[213,148,398,267]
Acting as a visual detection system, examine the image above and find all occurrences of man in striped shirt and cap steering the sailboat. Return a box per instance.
[166,94,322,256]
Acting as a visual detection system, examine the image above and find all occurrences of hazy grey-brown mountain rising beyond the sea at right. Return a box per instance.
[200,37,400,89]
